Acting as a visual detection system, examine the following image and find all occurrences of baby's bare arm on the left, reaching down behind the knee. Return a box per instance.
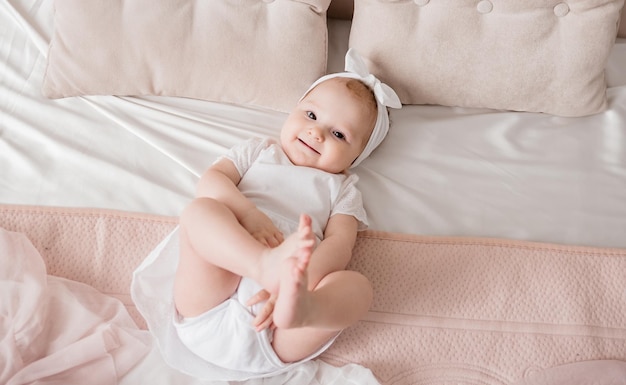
[196,158,283,247]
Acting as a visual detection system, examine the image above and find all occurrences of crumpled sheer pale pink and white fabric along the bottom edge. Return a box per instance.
[0,228,378,385]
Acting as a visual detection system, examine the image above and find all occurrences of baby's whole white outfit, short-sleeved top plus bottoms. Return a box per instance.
[131,139,367,381]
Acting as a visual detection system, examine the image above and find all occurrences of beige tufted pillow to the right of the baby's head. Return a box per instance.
[350,0,624,116]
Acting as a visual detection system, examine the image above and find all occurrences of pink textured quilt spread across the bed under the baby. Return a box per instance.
[0,205,626,385]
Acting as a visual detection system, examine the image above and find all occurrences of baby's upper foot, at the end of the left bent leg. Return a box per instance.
[258,215,315,293]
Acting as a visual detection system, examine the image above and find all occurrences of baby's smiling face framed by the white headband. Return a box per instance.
[280,78,376,174]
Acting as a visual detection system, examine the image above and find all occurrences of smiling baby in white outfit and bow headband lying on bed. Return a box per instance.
[133,50,401,380]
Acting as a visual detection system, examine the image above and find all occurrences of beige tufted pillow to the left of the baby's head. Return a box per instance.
[43,0,330,111]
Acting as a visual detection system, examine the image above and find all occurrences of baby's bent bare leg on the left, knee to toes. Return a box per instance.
[174,198,314,317]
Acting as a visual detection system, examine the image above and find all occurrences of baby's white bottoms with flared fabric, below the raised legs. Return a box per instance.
[131,229,334,381]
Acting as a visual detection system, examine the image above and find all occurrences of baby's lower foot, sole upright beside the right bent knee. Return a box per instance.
[274,216,315,328]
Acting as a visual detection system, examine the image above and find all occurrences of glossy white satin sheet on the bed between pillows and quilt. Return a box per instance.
[0,0,626,384]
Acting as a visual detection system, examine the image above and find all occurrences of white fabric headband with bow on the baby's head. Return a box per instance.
[300,48,402,168]
